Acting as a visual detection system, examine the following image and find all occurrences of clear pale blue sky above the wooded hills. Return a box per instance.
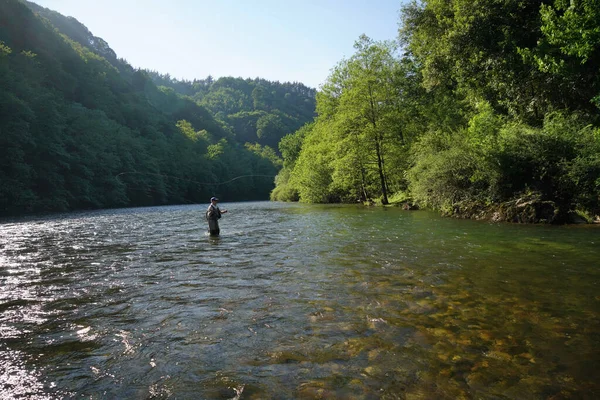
[33,0,405,88]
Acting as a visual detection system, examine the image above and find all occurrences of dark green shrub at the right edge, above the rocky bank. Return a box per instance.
[496,113,600,221]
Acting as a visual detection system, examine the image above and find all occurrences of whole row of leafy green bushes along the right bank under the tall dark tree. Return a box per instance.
[406,107,600,222]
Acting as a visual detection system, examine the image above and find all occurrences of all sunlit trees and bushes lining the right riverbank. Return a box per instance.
[271,0,600,223]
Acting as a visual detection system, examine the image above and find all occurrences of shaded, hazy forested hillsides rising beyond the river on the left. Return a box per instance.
[0,0,316,216]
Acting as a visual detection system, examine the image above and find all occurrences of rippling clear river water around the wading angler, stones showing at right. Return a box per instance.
[0,202,600,399]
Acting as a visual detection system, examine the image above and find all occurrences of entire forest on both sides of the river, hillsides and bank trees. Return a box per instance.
[0,0,600,223]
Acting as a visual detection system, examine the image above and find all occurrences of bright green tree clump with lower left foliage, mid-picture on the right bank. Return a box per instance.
[275,35,421,204]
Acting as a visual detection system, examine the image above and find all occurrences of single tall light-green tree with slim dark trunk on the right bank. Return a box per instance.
[320,35,401,204]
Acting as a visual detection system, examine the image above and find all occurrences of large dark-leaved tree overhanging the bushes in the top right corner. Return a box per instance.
[401,0,600,124]
